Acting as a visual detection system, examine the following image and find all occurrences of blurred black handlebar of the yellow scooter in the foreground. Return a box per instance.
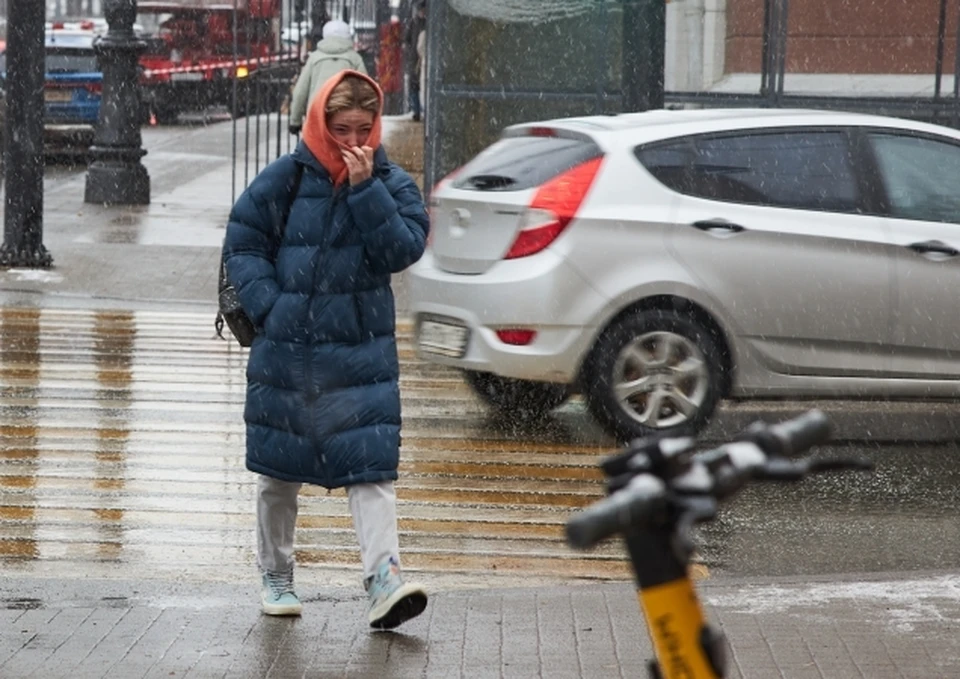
[566,410,873,549]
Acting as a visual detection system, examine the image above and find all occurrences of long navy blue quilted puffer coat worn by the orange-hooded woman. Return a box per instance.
[224,142,429,488]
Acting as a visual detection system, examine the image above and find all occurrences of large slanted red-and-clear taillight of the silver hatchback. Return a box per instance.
[504,156,603,259]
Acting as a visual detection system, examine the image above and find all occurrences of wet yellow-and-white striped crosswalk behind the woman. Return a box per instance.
[0,306,712,579]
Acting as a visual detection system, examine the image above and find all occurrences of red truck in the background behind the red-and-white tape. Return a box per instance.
[137,0,300,123]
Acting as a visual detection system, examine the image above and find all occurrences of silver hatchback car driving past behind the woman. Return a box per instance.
[410,109,960,439]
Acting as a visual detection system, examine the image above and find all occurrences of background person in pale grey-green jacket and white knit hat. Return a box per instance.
[288,21,367,134]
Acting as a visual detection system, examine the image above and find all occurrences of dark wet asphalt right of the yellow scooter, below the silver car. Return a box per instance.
[701,444,960,575]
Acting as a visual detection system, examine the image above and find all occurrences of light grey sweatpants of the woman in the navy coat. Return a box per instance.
[257,475,400,578]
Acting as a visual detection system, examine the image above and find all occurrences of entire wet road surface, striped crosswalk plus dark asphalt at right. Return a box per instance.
[0,308,960,586]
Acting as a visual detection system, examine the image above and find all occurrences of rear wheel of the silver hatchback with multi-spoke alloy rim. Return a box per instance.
[583,309,723,441]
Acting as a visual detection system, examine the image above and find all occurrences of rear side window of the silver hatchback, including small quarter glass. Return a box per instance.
[636,130,860,212]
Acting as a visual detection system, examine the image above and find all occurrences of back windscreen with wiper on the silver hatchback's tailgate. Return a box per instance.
[453,136,602,191]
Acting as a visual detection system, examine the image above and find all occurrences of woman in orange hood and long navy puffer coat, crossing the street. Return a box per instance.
[224,70,429,629]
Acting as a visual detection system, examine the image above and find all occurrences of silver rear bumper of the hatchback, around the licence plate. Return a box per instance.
[408,250,606,383]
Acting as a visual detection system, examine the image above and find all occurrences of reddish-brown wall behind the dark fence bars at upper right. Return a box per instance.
[725,0,960,74]
